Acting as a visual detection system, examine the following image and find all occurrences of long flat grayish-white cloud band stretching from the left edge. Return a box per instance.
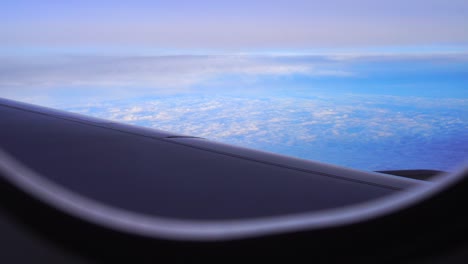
[0,55,351,93]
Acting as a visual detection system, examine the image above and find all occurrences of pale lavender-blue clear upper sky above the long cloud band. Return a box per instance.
[0,0,468,50]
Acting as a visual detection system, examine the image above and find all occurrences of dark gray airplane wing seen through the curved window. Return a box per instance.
[0,100,420,224]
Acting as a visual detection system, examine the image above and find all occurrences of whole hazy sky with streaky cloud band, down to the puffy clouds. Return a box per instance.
[0,0,468,111]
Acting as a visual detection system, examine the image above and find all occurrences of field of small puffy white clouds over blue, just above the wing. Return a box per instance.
[69,95,468,170]
